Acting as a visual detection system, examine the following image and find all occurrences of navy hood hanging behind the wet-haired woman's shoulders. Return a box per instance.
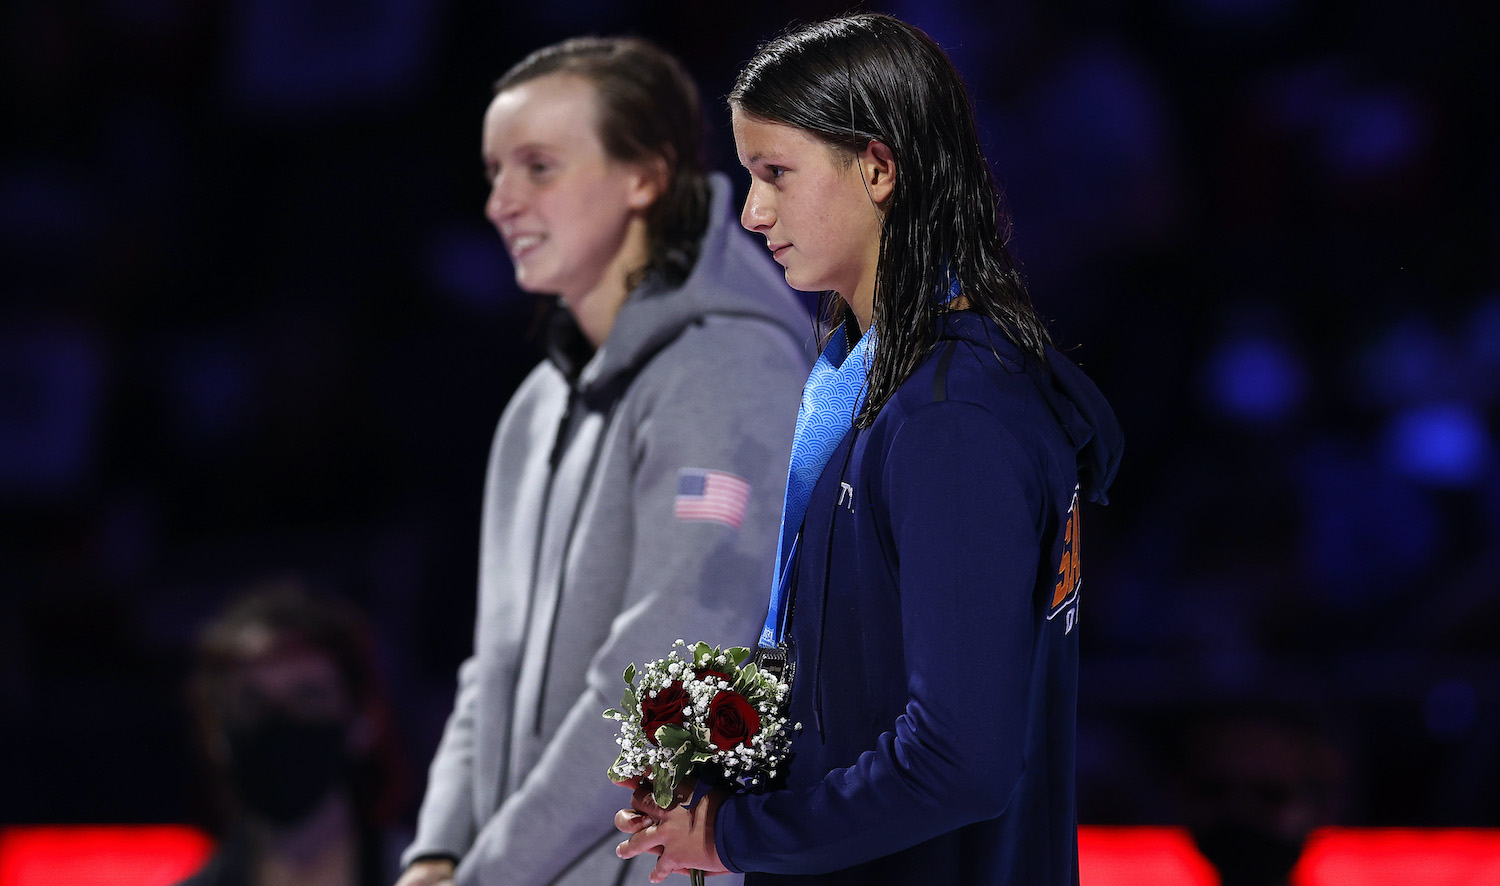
[939,310,1125,504]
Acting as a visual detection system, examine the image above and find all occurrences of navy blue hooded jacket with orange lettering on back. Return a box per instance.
[716,312,1121,886]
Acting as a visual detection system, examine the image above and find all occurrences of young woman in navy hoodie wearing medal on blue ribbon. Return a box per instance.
[615,15,1121,885]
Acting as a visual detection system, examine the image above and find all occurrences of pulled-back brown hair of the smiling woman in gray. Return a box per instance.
[495,37,708,288]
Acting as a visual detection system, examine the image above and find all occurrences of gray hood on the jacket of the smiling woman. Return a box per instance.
[548,172,813,396]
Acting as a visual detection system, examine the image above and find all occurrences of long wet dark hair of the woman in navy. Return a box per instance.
[729,13,1050,427]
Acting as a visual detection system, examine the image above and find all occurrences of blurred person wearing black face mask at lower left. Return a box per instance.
[183,582,401,886]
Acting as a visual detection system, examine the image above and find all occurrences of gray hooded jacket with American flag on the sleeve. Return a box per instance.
[404,175,815,886]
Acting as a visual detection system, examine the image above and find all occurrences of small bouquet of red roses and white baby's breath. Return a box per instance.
[605,640,800,810]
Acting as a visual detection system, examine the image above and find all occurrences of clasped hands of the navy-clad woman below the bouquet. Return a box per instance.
[615,778,729,883]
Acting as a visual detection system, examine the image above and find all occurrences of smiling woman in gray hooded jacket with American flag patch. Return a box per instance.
[399,37,813,886]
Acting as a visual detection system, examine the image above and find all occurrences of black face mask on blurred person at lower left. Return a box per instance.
[227,714,350,825]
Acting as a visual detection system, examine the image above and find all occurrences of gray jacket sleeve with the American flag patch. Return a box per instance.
[456,322,806,886]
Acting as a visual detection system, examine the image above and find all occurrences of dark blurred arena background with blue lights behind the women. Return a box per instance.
[0,0,1500,886]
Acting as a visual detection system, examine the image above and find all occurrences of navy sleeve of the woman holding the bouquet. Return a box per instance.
[716,402,1044,874]
